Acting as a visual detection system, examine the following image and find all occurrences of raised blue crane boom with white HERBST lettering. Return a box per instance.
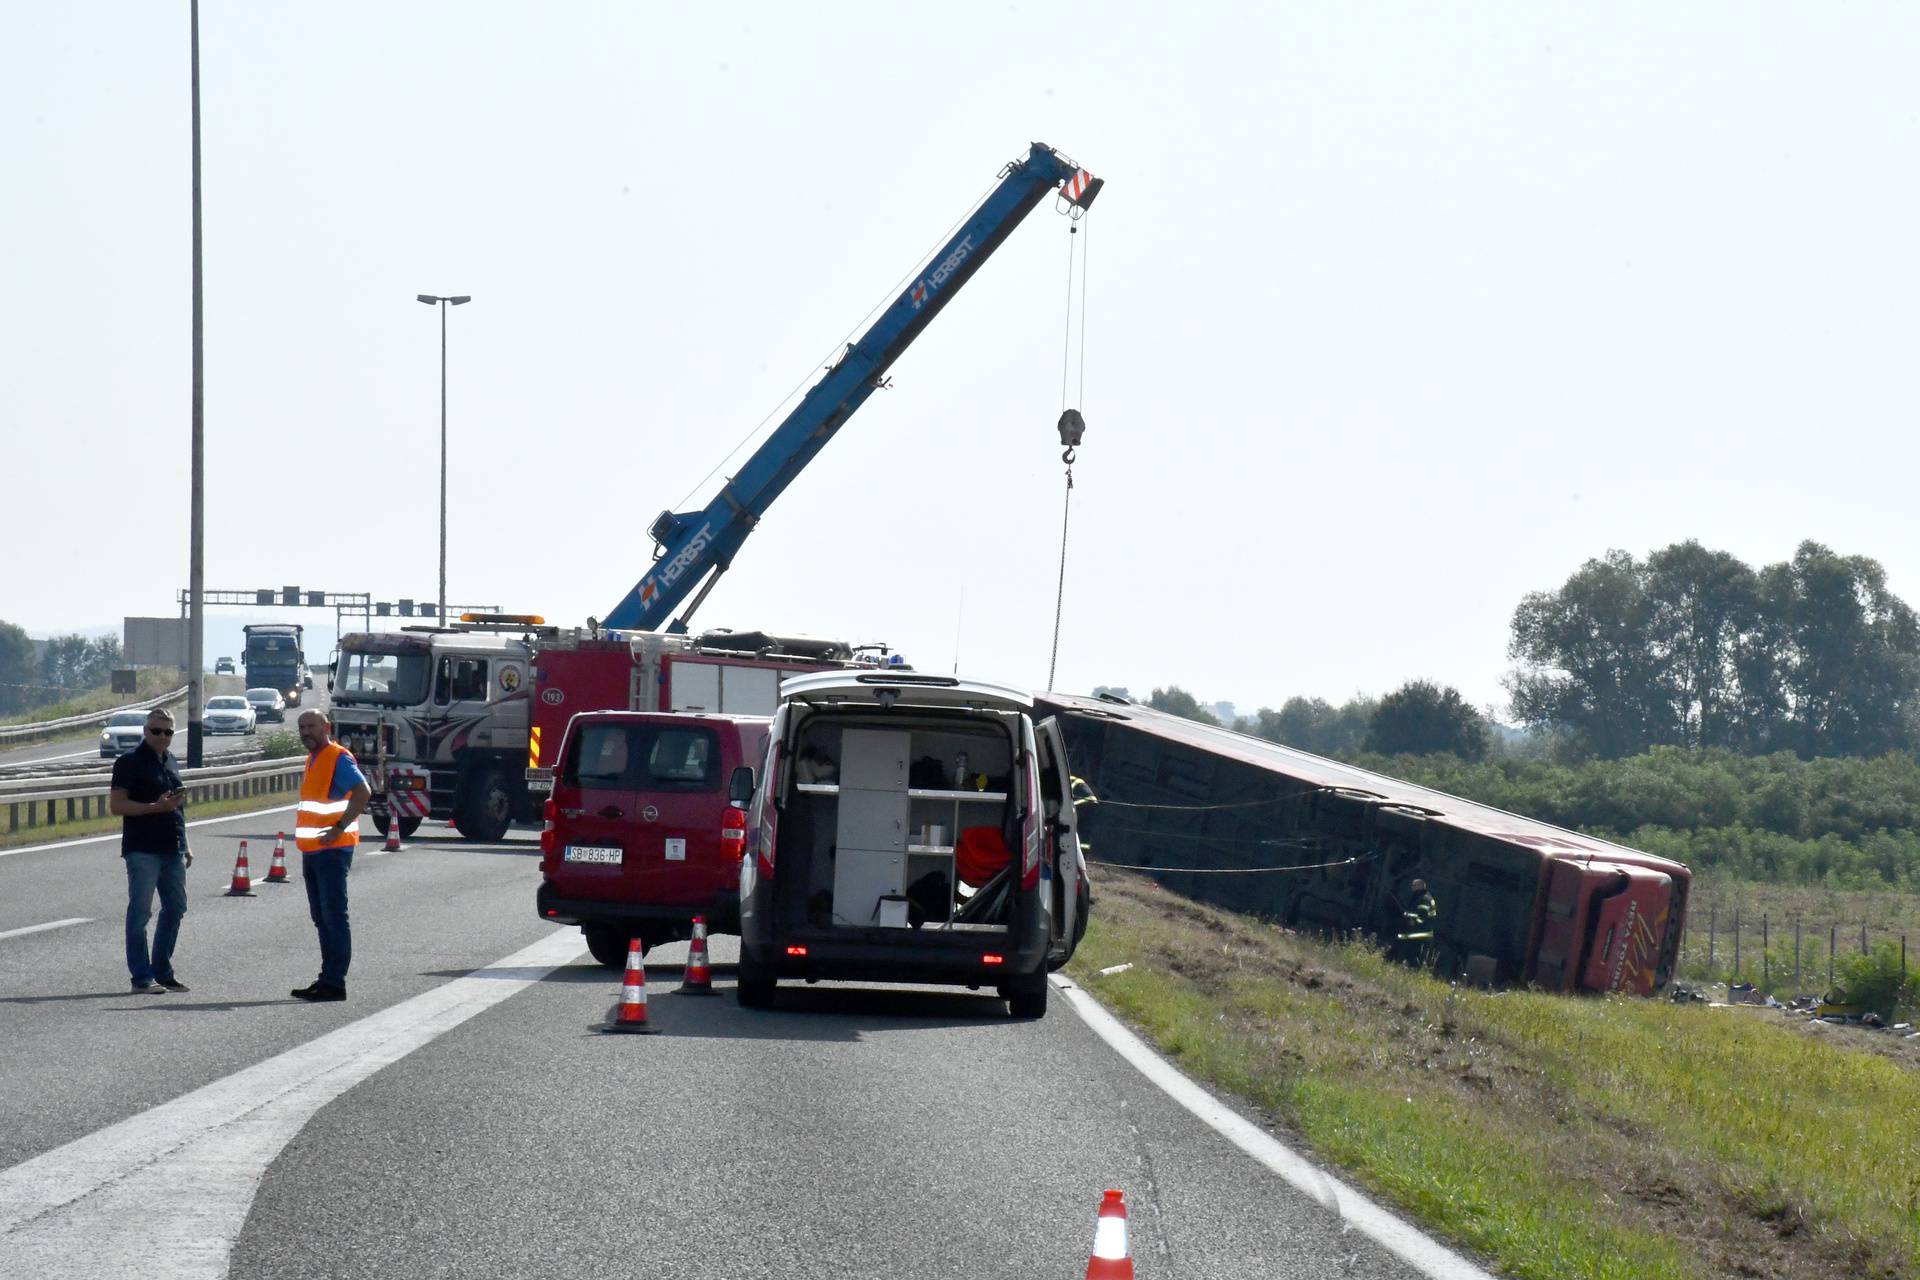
[603,142,1104,631]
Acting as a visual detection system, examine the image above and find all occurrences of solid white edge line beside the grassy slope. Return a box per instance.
[1052,975,1494,1280]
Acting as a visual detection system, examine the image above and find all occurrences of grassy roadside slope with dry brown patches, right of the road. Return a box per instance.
[1069,871,1920,1280]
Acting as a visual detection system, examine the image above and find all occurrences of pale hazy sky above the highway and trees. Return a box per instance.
[0,0,1920,710]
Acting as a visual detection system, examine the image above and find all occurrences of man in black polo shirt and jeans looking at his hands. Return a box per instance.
[108,708,194,992]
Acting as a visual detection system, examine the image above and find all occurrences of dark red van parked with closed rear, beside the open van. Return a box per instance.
[534,712,770,969]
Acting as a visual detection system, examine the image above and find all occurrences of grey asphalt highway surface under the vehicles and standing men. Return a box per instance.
[0,814,1474,1280]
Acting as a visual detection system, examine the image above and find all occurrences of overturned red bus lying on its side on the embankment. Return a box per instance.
[1037,693,1692,994]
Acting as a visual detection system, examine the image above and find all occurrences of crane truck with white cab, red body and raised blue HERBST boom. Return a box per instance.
[332,142,1102,841]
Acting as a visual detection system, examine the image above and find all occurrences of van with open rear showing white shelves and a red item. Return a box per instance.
[737,672,1089,1017]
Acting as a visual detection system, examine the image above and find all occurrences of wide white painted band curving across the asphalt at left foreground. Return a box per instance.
[0,929,582,1280]
